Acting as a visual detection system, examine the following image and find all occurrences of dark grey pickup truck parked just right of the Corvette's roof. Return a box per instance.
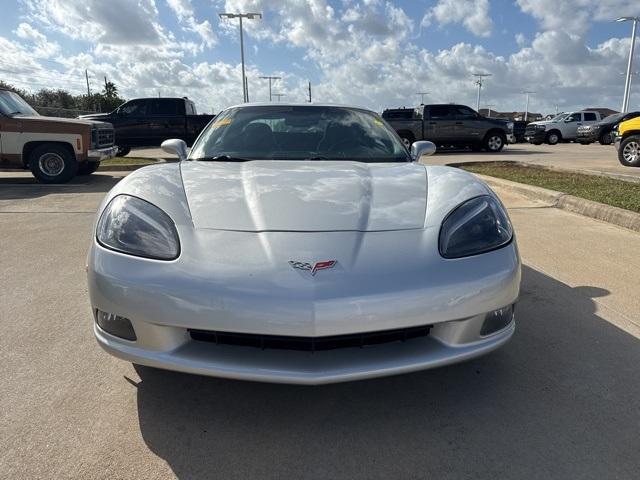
[382,104,515,152]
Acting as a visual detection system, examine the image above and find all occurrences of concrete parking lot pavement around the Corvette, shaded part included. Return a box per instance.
[0,145,640,479]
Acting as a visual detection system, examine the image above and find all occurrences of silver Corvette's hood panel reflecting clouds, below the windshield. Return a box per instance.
[181,160,427,232]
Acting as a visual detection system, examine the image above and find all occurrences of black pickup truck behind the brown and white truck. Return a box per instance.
[80,97,214,156]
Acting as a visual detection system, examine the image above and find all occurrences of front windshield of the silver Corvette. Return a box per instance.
[190,105,411,162]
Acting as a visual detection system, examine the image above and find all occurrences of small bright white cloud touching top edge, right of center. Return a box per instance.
[421,0,493,37]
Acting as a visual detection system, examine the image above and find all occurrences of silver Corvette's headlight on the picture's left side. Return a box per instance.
[96,195,180,260]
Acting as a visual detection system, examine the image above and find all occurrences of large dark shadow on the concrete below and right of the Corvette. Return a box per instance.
[131,267,640,479]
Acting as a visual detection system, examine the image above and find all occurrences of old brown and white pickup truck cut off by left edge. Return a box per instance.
[0,90,117,183]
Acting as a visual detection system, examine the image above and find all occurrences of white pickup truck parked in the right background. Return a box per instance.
[524,110,603,145]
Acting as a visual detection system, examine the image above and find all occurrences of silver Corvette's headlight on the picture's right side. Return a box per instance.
[439,195,513,258]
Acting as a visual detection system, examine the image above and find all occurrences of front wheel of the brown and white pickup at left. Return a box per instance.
[29,143,78,183]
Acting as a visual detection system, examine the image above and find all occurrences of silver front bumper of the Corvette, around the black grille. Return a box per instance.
[88,228,520,384]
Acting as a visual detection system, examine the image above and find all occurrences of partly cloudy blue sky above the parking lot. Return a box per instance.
[0,0,640,113]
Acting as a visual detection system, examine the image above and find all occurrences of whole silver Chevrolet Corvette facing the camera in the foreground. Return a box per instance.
[88,104,520,384]
